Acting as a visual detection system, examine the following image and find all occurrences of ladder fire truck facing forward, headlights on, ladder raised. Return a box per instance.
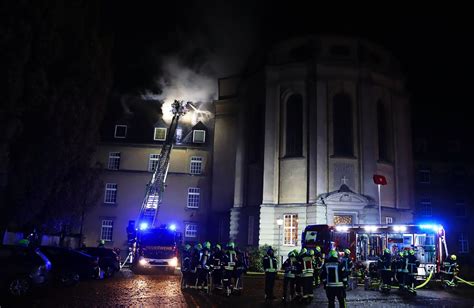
[127,100,190,272]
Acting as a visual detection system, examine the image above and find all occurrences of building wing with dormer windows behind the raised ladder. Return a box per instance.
[83,97,214,251]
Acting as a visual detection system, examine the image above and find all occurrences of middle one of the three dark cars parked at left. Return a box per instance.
[40,246,102,285]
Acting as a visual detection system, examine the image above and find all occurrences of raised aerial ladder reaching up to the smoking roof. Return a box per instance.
[121,100,188,267]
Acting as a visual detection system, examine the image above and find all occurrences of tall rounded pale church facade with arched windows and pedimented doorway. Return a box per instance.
[218,37,414,253]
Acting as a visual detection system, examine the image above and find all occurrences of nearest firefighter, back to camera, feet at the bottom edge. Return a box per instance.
[321,250,346,307]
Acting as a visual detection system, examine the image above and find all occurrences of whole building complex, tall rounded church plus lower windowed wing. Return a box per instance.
[82,36,414,258]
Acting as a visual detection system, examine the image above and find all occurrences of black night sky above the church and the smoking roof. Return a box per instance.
[115,1,474,137]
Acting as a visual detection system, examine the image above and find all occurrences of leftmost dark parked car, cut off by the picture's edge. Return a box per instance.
[0,245,51,296]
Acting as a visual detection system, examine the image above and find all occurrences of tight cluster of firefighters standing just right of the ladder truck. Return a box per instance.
[181,242,248,295]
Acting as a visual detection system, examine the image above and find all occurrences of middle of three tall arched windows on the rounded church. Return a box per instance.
[333,94,354,156]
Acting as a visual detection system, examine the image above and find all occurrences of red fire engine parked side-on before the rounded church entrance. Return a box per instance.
[301,224,448,277]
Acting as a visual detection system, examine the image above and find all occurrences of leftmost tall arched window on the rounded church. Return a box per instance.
[285,94,303,157]
